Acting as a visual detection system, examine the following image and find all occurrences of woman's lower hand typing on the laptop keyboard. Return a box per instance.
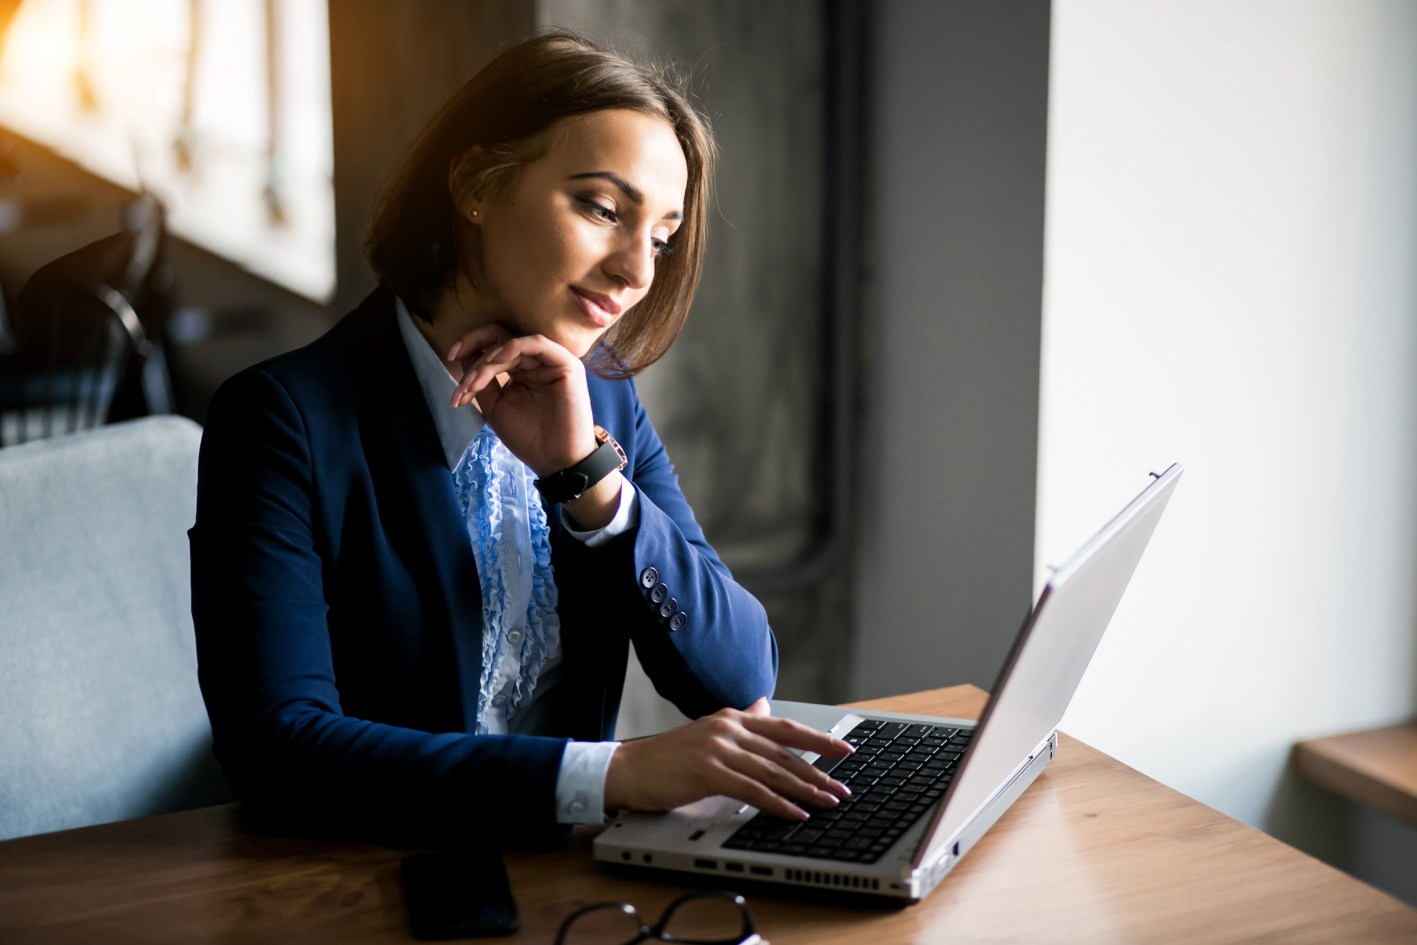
[605,698,854,820]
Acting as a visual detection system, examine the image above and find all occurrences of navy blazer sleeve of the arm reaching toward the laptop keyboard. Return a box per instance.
[190,370,565,846]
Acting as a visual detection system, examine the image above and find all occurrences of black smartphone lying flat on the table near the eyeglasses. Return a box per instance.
[400,850,521,938]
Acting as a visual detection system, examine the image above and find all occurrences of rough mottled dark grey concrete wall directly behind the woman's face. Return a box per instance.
[537,0,852,734]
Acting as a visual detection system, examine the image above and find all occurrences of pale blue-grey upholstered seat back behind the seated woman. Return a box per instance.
[0,417,234,839]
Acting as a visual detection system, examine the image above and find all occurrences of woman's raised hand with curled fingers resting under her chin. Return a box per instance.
[446,324,622,528]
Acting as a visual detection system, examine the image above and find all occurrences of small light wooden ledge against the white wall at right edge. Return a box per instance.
[1294,723,1417,827]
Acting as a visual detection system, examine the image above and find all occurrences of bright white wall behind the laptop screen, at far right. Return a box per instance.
[1037,0,1417,826]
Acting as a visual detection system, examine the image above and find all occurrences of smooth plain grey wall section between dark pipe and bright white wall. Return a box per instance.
[852,0,1049,697]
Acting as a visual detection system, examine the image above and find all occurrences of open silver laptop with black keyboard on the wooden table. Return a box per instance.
[594,463,1183,904]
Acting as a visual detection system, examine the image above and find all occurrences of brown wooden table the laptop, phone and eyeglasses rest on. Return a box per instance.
[0,686,1417,945]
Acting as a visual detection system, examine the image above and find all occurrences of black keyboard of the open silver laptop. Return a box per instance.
[723,718,973,863]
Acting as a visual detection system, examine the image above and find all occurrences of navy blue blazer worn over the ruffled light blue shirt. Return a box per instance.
[190,288,778,843]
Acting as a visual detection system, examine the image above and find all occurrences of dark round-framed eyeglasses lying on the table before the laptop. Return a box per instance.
[555,890,768,945]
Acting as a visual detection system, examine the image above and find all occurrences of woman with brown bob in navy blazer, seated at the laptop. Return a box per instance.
[191,35,849,843]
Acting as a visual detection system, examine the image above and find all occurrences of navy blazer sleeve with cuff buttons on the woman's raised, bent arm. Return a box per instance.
[600,381,778,718]
